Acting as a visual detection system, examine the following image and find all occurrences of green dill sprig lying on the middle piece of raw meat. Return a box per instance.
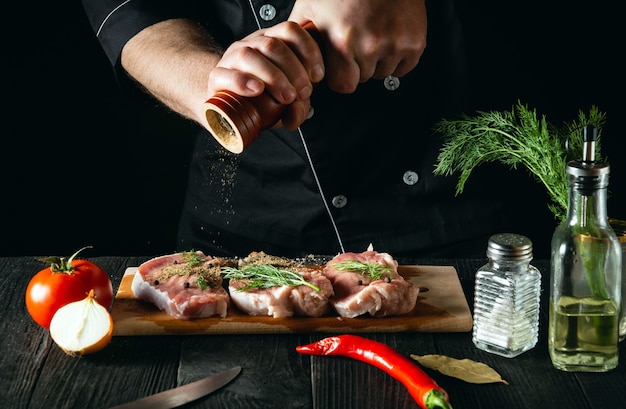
[222,264,320,291]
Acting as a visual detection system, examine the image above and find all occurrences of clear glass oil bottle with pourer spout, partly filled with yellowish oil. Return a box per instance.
[548,126,622,372]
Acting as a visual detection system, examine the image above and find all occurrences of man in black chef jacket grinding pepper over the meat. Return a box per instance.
[83,0,544,257]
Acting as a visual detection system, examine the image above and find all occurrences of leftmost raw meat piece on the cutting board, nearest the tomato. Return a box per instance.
[131,251,229,320]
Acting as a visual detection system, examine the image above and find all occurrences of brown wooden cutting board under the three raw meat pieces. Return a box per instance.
[111,266,472,336]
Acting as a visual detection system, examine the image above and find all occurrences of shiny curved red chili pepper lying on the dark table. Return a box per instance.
[296,334,452,409]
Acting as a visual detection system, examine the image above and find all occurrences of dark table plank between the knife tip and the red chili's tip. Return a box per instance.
[179,335,313,409]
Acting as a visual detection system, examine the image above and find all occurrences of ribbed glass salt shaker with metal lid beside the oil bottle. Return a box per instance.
[472,233,541,358]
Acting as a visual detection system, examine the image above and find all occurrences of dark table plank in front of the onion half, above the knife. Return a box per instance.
[29,337,181,409]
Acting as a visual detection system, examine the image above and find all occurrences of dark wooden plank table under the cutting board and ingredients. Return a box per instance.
[0,257,626,409]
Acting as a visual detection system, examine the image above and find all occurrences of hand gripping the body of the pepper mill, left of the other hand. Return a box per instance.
[208,21,324,129]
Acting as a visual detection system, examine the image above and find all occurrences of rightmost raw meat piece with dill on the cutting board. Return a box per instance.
[324,248,419,318]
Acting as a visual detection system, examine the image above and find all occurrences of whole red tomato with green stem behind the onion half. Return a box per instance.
[26,245,113,328]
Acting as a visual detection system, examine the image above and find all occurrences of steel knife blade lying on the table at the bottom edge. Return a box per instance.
[109,366,241,409]
